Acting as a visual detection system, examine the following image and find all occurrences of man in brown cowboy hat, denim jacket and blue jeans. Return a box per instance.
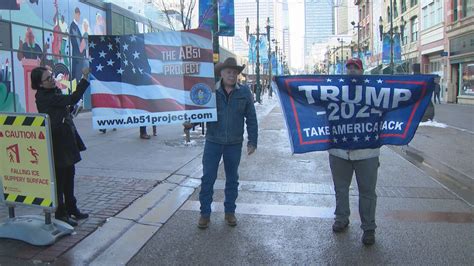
[198,58,258,229]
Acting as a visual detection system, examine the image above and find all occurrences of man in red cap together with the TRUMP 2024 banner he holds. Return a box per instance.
[275,59,435,245]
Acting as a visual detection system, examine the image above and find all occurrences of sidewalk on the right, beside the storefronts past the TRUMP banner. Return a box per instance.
[392,104,474,207]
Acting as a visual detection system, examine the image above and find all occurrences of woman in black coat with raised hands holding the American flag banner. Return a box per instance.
[31,67,89,226]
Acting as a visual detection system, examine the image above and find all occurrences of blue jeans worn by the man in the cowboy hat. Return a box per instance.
[199,141,242,217]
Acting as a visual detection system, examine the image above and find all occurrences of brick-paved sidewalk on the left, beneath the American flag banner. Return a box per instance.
[0,113,204,264]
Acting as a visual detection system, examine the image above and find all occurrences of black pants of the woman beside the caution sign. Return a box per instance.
[55,165,77,217]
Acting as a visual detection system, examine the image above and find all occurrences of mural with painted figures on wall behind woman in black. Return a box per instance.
[6,0,106,112]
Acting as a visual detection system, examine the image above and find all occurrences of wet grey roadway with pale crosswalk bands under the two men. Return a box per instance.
[128,107,474,265]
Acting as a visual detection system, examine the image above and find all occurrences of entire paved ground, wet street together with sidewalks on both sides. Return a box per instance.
[0,97,474,265]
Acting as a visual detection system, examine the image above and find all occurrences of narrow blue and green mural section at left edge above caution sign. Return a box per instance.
[0,51,24,112]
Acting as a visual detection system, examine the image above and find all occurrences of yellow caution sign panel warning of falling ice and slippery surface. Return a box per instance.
[0,113,56,208]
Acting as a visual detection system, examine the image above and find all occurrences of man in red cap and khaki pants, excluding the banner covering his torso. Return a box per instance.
[328,58,380,245]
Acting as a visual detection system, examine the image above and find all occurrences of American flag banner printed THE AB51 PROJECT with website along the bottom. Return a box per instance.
[89,30,217,129]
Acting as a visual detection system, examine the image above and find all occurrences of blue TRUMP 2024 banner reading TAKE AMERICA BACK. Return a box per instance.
[275,75,435,153]
